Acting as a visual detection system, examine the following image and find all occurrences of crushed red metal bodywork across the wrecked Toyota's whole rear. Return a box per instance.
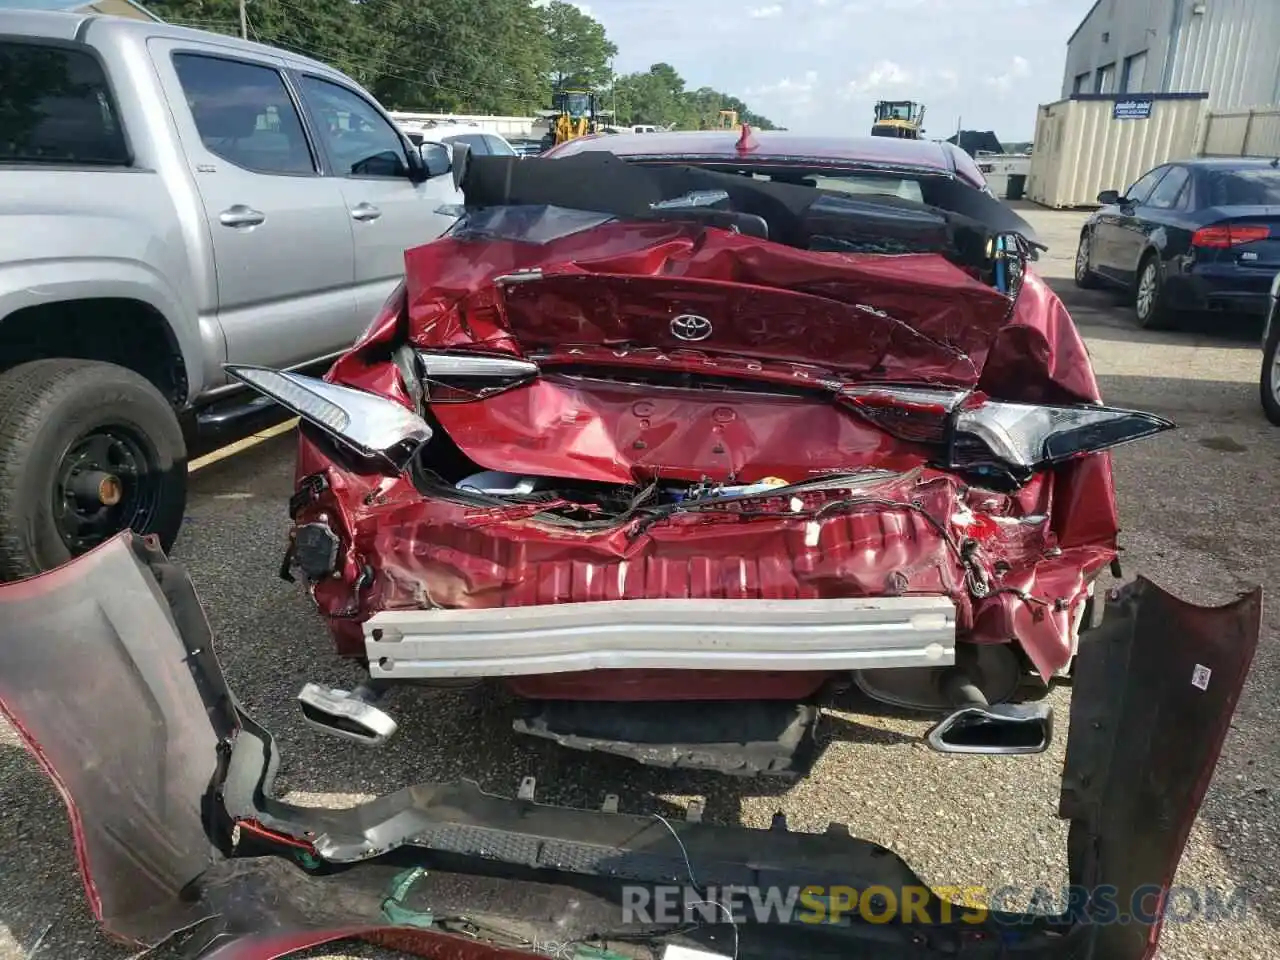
[296,215,1117,699]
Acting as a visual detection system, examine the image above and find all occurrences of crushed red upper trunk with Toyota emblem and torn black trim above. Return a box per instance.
[406,154,1034,385]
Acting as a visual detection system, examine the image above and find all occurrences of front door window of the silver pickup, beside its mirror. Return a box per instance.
[302,76,408,177]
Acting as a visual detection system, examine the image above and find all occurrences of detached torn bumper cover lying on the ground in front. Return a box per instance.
[0,534,1261,960]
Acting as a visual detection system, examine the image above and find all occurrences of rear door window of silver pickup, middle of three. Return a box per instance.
[173,54,316,174]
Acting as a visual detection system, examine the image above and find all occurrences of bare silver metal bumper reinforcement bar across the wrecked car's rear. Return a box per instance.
[364,596,956,680]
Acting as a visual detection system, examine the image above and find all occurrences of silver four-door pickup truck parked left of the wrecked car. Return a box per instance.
[0,10,460,581]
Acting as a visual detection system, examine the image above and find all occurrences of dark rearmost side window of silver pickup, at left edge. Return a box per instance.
[0,41,129,166]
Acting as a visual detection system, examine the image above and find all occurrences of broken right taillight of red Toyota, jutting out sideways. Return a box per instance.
[841,387,1174,481]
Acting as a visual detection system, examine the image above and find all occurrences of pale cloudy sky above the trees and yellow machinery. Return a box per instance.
[576,0,1093,142]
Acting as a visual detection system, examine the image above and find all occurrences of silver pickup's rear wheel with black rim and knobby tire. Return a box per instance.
[0,360,187,582]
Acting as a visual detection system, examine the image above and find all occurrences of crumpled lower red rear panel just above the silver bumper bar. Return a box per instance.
[298,438,1114,680]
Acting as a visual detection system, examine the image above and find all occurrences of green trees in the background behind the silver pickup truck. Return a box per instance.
[147,0,773,129]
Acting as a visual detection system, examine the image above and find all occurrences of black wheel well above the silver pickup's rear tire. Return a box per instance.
[0,297,188,407]
